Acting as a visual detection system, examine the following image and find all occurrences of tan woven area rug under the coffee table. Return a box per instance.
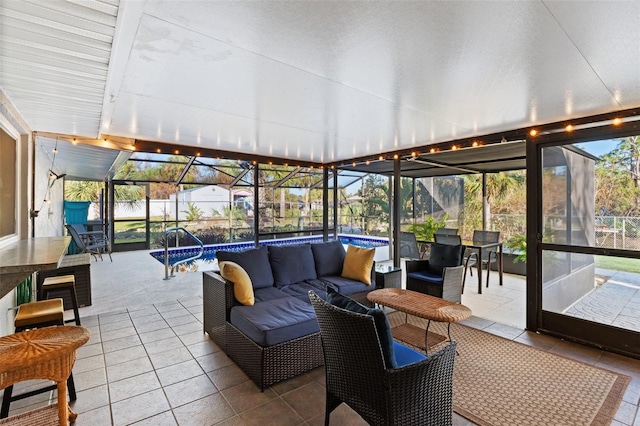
[389,312,630,426]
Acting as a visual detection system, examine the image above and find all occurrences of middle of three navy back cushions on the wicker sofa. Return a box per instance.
[269,244,318,287]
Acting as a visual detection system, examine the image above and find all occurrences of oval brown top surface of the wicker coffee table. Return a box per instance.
[367,288,471,322]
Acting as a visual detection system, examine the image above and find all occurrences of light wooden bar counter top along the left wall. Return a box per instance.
[0,236,71,298]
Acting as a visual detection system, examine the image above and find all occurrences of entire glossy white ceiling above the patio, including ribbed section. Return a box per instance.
[0,0,640,178]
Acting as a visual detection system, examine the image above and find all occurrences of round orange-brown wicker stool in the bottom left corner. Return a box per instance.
[0,326,91,425]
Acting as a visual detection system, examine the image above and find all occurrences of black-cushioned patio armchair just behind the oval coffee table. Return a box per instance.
[405,243,465,303]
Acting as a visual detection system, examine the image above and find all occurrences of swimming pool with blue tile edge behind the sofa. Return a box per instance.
[149,234,389,271]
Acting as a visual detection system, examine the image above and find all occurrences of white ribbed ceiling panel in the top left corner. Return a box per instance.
[0,0,118,137]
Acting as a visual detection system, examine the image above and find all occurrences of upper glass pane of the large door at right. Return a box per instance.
[542,136,640,250]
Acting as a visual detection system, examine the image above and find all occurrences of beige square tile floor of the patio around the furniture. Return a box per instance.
[1,252,640,426]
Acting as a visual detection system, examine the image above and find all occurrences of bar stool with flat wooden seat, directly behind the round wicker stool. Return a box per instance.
[0,298,76,419]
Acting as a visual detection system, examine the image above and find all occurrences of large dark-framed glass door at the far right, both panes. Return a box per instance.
[537,136,640,356]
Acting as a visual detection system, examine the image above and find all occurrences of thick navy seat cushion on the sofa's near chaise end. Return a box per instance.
[230,296,320,346]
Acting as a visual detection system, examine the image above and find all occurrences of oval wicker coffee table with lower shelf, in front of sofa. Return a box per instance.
[367,288,471,353]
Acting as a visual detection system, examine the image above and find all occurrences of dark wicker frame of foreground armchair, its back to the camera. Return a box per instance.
[309,292,456,426]
